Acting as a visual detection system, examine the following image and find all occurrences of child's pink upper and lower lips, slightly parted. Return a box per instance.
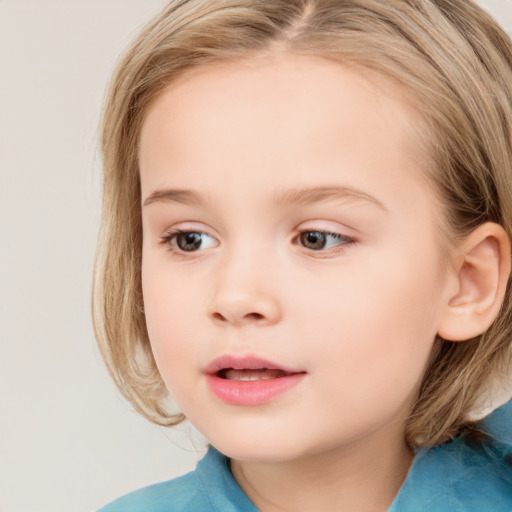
[204,356,306,406]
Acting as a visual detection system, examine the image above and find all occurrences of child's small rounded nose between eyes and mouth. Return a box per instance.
[208,253,282,326]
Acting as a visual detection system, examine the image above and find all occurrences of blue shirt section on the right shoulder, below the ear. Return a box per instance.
[389,402,512,512]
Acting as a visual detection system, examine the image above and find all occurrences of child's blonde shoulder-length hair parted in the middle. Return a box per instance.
[93,0,512,446]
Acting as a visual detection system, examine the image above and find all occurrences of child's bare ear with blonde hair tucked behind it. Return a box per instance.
[437,222,511,341]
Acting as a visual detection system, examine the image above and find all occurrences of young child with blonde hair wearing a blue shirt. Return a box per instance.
[94,0,512,512]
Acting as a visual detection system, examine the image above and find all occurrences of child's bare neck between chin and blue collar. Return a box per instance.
[231,428,413,512]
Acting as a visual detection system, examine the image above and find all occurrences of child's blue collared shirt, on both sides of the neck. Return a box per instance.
[99,402,512,512]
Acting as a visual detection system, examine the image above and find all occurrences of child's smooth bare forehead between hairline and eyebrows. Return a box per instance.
[139,55,432,208]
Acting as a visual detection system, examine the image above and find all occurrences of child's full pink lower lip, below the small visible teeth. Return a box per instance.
[207,373,305,405]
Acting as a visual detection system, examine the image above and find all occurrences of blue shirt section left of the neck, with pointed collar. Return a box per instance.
[98,447,257,512]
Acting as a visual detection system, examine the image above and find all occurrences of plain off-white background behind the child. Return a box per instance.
[0,0,512,512]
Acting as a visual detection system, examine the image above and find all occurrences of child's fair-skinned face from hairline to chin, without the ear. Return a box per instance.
[140,56,448,460]
